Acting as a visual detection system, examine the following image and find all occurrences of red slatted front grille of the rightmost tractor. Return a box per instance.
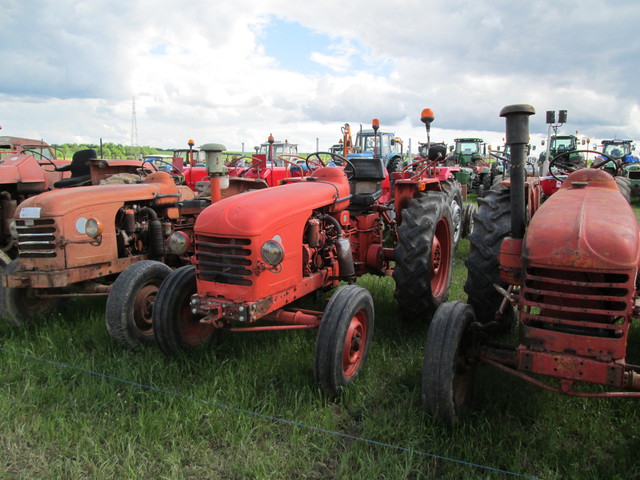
[522,268,633,338]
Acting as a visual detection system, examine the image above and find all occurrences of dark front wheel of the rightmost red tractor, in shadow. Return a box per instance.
[422,301,476,425]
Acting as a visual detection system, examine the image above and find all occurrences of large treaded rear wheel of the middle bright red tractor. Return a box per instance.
[393,192,453,318]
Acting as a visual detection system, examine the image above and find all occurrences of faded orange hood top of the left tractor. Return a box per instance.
[16,172,193,217]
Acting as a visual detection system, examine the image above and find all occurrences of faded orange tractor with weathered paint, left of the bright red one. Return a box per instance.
[2,144,266,348]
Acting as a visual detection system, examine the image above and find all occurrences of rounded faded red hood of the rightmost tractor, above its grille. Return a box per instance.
[524,169,640,270]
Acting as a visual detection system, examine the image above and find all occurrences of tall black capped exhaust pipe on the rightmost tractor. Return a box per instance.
[500,104,536,239]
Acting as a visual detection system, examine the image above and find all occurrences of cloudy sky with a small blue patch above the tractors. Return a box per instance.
[0,0,640,152]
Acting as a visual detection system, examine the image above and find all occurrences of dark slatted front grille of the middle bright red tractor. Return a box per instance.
[196,235,253,286]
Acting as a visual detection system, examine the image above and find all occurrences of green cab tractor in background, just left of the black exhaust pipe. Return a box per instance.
[445,138,491,197]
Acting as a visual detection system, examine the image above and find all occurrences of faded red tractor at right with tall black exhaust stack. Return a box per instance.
[422,105,640,423]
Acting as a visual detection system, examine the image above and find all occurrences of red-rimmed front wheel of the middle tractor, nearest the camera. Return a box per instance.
[313,285,374,398]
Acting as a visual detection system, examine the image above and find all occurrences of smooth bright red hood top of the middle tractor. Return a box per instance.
[195,167,349,237]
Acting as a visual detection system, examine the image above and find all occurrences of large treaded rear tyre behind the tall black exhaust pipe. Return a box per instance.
[464,186,511,323]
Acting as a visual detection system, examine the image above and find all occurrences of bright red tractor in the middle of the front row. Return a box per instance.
[153,113,453,396]
